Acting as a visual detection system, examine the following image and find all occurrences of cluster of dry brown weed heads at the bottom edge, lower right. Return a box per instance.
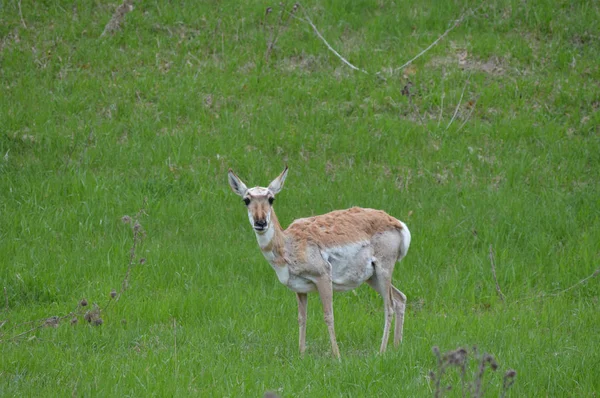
[429,346,517,398]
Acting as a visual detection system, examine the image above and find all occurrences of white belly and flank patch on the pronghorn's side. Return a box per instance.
[321,242,374,291]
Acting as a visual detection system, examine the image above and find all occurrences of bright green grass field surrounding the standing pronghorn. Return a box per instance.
[0,0,600,397]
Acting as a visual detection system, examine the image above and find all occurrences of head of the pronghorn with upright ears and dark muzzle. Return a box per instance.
[228,166,288,234]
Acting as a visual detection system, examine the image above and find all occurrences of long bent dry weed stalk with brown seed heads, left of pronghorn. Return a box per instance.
[0,199,147,343]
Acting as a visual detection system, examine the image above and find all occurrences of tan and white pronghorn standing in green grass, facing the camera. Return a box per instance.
[228,166,410,358]
